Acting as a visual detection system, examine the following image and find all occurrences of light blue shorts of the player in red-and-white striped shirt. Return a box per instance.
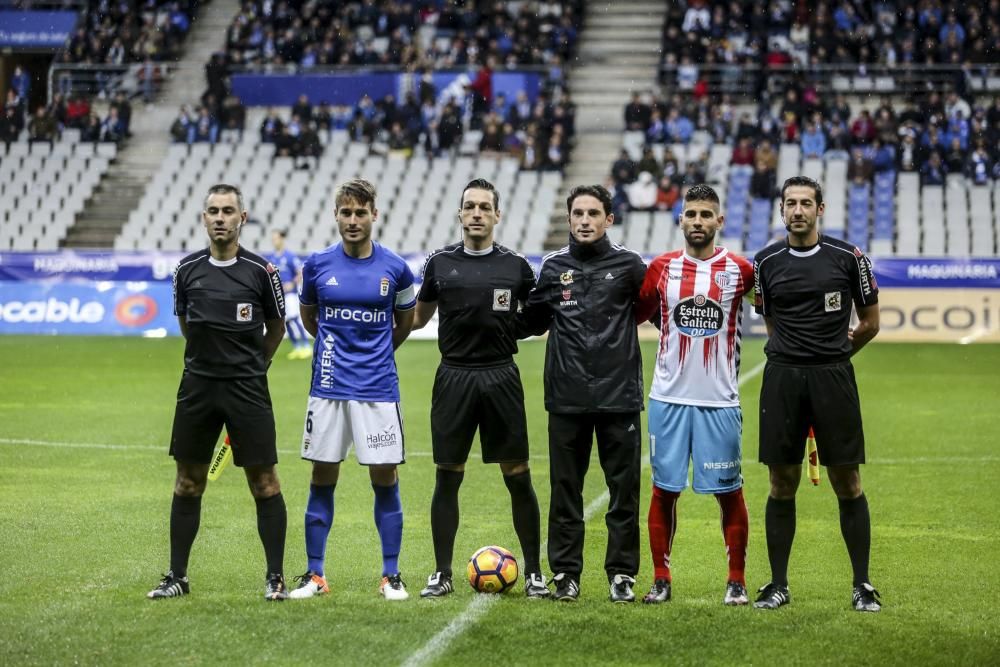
[649,400,743,493]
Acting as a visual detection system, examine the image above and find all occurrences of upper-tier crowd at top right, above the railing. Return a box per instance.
[663,0,1000,81]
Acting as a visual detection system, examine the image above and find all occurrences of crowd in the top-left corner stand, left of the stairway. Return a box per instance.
[56,0,198,65]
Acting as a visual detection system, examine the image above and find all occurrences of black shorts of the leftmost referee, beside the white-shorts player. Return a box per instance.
[170,372,278,466]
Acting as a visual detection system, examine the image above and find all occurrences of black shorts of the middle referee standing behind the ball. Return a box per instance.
[431,362,528,464]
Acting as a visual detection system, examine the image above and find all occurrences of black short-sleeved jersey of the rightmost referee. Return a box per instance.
[753,235,878,364]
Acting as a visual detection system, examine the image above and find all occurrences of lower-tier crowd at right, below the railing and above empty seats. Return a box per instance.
[611,87,1000,210]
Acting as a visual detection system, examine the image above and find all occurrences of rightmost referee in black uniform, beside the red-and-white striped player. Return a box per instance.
[754,176,881,611]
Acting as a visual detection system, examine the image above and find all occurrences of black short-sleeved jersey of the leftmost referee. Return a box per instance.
[174,247,285,378]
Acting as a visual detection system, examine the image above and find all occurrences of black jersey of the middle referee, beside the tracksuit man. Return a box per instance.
[417,243,535,366]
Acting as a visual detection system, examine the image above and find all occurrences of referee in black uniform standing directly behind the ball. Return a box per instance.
[413,178,549,598]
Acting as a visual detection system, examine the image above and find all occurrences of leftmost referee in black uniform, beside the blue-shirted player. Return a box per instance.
[147,184,288,600]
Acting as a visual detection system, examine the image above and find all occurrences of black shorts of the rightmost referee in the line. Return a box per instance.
[760,361,865,466]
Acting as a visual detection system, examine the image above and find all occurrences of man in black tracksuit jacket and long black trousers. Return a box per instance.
[520,185,646,602]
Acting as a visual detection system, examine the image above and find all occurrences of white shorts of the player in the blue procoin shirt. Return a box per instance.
[302,396,406,465]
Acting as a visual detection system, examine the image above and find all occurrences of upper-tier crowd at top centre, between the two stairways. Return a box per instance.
[226,0,584,69]
